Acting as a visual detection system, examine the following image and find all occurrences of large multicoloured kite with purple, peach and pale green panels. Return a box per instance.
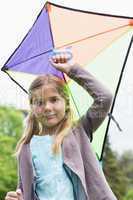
[2,2,133,160]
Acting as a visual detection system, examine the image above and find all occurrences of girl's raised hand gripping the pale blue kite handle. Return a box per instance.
[49,51,75,74]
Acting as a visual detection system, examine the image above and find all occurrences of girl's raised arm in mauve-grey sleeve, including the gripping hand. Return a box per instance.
[50,53,112,139]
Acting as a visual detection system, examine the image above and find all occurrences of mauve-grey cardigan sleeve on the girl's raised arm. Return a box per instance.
[67,65,112,140]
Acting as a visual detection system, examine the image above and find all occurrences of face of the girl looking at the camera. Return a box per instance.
[31,84,66,128]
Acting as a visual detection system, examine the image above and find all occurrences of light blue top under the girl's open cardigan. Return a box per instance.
[30,135,74,200]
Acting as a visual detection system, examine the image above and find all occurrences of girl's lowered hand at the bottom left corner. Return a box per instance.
[5,189,24,200]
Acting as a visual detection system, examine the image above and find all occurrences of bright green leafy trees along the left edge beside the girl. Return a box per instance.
[0,107,23,199]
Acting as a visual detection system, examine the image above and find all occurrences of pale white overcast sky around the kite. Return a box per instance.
[0,0,133,153]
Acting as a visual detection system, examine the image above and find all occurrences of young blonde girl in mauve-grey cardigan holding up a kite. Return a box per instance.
[5,52,116,200]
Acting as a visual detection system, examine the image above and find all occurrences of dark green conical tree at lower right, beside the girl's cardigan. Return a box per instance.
[103,140,129,200]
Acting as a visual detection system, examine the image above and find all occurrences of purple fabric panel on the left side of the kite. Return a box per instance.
[5,8,53,73]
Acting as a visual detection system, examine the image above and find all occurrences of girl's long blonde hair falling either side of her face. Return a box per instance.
[15,75,73,156]
